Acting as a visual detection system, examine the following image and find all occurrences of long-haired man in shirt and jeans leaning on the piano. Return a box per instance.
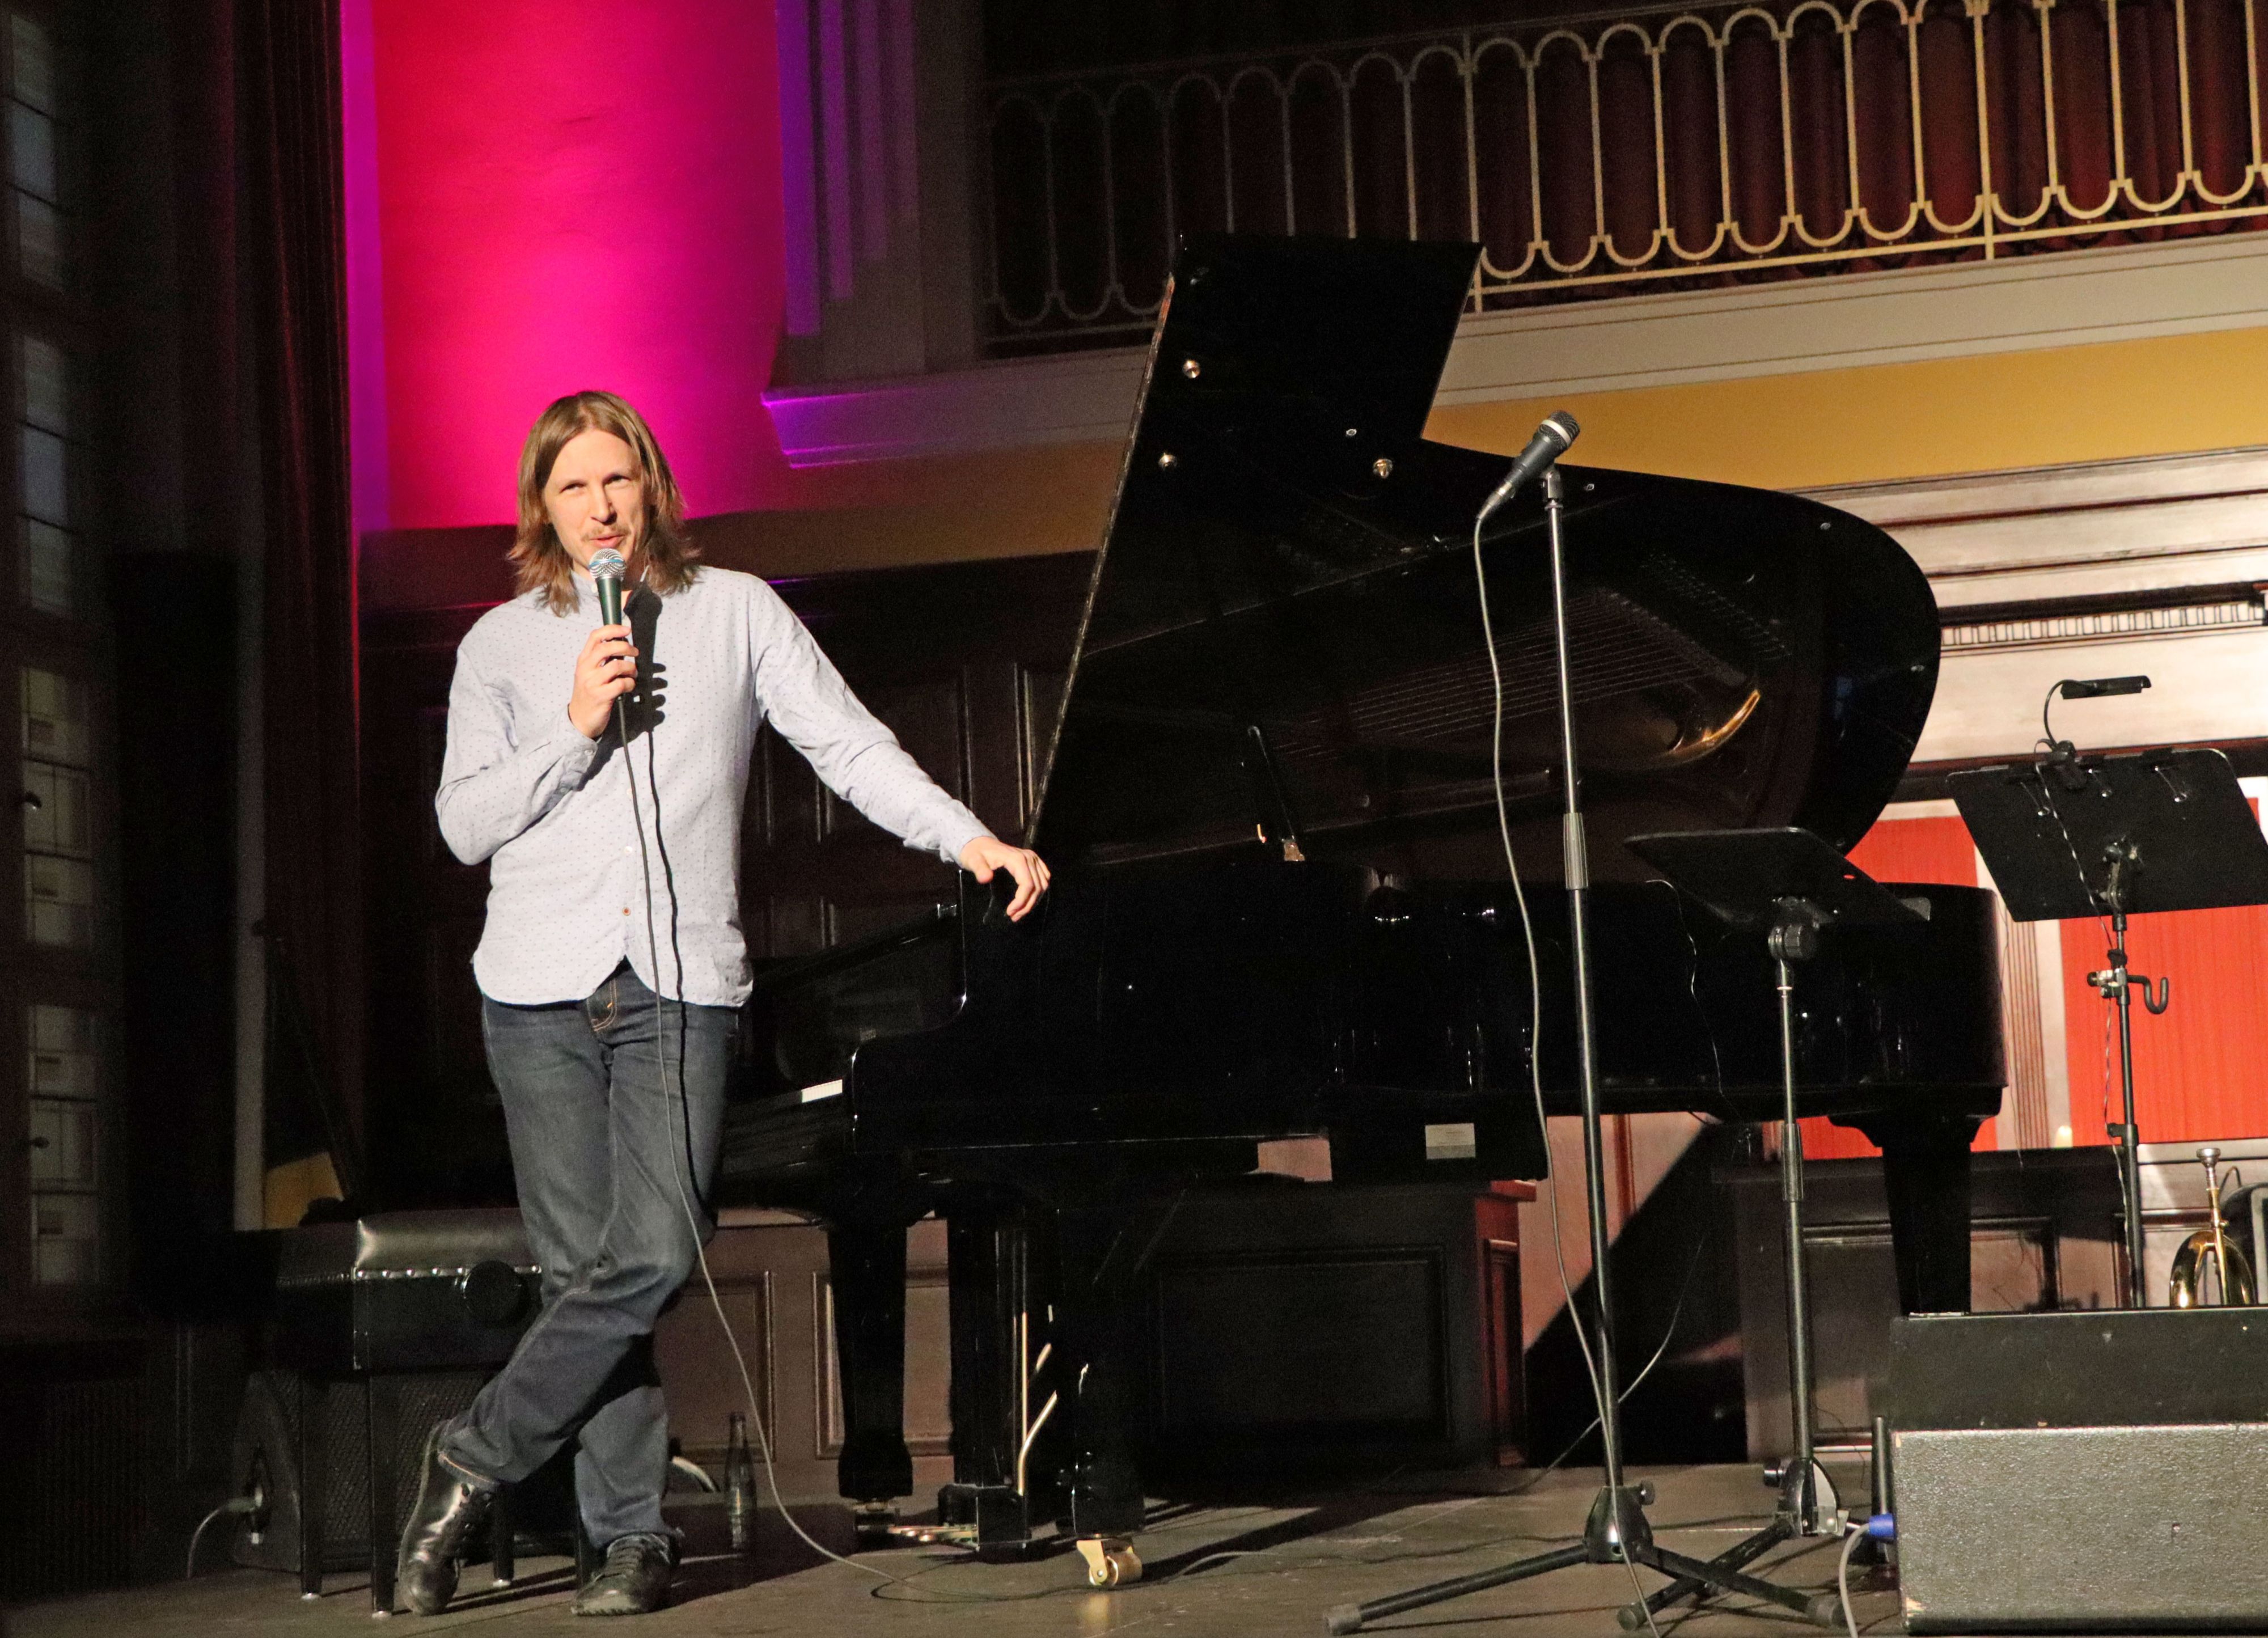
[399,392,1048,1615]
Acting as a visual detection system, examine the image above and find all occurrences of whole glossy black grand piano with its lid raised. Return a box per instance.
[719,238,2003,1584]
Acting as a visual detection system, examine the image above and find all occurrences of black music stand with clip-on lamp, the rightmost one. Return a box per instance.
[1948,751,2268,1307]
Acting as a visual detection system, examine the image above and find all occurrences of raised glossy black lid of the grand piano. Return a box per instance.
[1030,236,1937,878]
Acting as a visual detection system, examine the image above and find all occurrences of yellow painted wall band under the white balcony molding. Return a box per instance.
[703,329,2268,574]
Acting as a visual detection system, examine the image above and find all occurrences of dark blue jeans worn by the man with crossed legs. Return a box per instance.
[440,962,735,1547]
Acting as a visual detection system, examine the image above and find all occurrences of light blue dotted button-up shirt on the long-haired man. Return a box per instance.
[433,567,989,1008]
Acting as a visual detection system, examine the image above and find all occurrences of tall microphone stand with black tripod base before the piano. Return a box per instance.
[1325,463,1842,1633]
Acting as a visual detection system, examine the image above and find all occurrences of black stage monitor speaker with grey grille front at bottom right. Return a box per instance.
[1887,1309,2268,1633]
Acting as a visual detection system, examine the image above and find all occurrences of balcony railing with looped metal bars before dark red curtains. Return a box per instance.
[984,0,2268,354]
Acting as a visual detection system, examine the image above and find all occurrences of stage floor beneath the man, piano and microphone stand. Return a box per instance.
[5,1466,1898,1638]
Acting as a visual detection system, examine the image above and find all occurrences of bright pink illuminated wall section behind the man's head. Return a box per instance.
[345,0,787,533]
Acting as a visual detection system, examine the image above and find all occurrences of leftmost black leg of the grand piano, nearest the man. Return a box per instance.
[828,1218,914,1522]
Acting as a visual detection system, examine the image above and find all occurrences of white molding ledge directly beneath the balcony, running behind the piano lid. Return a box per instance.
[764,234,2268,467]
